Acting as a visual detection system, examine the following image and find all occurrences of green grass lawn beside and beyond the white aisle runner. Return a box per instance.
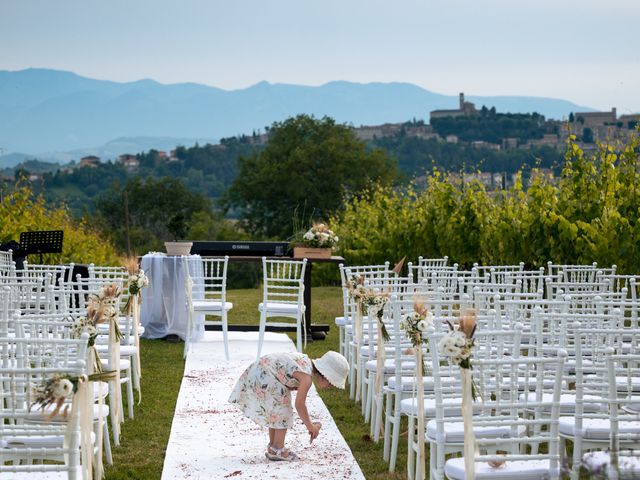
[105,287,406,480]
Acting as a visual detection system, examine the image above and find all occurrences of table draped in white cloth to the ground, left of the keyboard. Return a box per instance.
[140,253,204,340]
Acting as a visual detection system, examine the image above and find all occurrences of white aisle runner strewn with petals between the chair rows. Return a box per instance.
[162,332,364,480]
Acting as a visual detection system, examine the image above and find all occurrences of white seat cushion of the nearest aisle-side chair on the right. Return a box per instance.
[444,457,550,480]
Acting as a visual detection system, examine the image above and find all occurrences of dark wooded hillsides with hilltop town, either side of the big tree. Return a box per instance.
[3,93,640,196]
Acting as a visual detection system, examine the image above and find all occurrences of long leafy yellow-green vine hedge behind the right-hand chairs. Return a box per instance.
[330,133,640,273]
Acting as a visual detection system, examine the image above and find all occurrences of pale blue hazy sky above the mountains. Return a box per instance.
[0,0,640,114]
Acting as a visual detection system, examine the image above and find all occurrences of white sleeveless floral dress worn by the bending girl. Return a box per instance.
[229,353,313,429]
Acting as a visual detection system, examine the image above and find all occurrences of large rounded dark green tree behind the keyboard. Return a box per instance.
[224,115,396,238]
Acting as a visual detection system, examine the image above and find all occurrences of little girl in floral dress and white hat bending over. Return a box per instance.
[229,351,349,460]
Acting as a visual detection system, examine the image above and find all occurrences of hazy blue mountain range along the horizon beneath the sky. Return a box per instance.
[0,69,591,154]
